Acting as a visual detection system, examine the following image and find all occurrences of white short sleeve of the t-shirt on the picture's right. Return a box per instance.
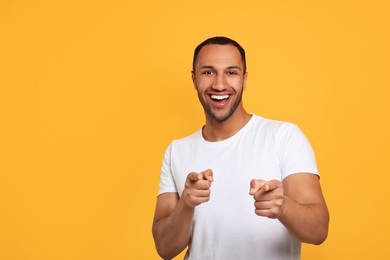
[276,123,319,179]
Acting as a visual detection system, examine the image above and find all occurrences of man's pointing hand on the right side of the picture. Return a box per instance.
[249,180,284,218]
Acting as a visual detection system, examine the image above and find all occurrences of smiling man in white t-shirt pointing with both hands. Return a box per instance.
[153,37,329,260]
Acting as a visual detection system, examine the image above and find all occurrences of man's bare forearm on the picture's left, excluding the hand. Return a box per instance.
[153,199,194,259]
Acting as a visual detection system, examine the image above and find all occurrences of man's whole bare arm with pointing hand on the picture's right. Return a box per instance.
[250,173,329,244]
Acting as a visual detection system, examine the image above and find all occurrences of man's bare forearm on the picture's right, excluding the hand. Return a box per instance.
[279,196,329,245]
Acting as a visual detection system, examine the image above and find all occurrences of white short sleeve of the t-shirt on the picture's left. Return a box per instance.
[157,144,177,195]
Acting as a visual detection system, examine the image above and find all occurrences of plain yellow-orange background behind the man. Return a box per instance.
[0,0,390,260]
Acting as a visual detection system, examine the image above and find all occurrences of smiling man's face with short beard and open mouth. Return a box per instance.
[192,45,247,122]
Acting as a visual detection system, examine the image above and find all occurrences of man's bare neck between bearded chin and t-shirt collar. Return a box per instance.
[203,108,252,142]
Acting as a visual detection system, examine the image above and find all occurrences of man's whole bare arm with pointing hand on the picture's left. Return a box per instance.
[152,170,213,259]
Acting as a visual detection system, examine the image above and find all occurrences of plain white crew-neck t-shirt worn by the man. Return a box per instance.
[158,115,318,260]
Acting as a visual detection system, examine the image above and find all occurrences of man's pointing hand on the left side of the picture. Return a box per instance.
[182,169,213,207]
